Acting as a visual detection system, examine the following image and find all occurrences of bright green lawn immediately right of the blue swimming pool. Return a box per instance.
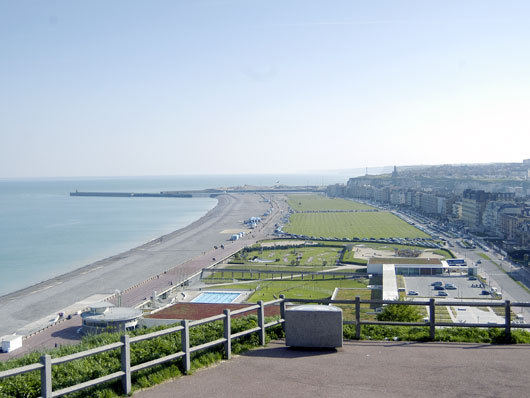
[208,279,367,303]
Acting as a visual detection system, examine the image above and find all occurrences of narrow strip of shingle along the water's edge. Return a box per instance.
[0,197,221,304]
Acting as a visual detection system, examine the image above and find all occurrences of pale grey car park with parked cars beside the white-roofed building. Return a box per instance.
[404,275,492,300]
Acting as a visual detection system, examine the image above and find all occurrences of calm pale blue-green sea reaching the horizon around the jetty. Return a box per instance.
[0,175,354,295]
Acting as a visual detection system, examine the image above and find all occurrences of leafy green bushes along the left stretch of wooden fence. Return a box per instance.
[0,316,283,398]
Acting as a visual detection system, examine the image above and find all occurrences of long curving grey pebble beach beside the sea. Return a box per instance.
[0,194,270,336]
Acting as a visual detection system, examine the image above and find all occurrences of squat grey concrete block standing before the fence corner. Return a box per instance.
[285,305,342,348]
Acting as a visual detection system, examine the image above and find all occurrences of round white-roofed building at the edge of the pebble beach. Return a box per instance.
[81,302,142,334]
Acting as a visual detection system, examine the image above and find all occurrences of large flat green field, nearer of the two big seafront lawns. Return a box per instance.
[284,211,429,238]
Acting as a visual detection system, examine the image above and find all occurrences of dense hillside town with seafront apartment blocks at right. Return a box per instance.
[327,159,530,265]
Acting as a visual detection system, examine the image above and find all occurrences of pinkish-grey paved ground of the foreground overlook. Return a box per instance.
[134,341,530,398]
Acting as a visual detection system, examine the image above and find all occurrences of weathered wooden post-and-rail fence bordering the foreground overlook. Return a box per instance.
[0,296,530,398]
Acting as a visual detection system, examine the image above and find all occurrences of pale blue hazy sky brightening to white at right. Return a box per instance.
[0,0,530,178]
